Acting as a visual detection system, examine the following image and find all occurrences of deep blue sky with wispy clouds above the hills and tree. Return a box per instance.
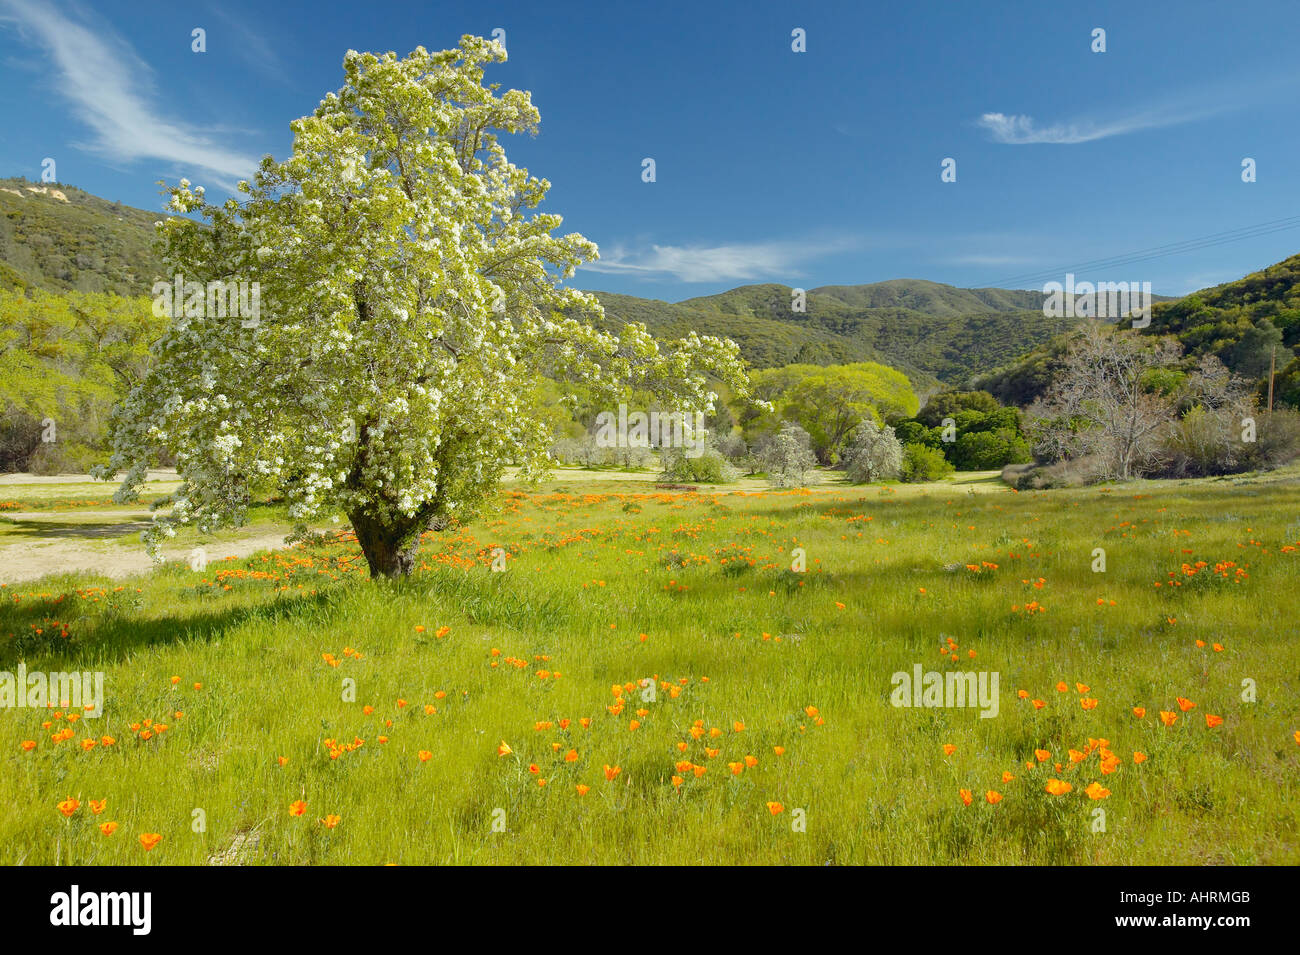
[0,0,1300,301]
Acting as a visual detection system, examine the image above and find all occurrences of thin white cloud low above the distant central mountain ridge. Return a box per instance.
[582,238,861,282]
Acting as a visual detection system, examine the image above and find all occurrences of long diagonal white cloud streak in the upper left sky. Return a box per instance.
[0,0,257,190]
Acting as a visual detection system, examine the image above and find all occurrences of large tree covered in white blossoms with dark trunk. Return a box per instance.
[100,36,748,577]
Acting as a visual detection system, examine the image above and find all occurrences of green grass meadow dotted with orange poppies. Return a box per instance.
[0,470,1300,864]
